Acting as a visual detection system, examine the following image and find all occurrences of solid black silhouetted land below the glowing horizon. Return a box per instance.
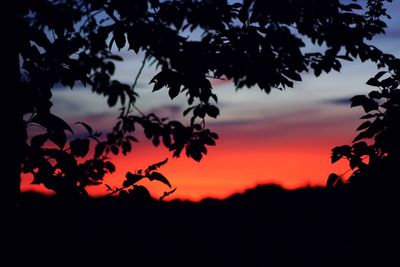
[14,186,400,267]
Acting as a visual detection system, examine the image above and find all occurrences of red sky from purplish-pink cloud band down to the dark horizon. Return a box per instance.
[24,102,359,200]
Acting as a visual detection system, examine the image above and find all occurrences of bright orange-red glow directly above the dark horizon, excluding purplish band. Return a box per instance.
[22,129,354,201]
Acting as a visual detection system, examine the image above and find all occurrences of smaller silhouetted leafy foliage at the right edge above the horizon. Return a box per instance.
[328,59,400,187]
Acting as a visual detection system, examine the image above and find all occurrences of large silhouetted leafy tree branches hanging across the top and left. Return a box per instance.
[13,0,391,201]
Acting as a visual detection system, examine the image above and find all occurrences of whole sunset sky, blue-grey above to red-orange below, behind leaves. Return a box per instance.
[23,1,400,200]
